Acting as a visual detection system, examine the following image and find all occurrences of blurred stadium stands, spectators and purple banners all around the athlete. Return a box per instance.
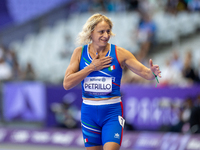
[0,0,200,150]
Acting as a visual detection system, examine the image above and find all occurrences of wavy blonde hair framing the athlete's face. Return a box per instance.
[76,13,115,45]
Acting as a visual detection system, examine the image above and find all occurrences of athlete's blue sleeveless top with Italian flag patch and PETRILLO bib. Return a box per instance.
[79,44,122,98]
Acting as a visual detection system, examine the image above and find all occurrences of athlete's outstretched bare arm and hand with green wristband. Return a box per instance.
[117,47,161,80]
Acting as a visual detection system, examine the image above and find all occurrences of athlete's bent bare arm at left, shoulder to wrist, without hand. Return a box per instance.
[63,47,95,90]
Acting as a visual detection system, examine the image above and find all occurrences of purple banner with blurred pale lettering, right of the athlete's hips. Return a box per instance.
[121,85,200,130]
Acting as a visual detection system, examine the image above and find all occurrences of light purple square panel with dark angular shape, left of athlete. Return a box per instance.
[3,82,46,122]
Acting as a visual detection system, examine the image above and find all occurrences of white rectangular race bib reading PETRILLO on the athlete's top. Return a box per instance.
[84,77,112,95]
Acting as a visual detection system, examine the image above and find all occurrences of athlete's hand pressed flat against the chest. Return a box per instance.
[91,54,112,71]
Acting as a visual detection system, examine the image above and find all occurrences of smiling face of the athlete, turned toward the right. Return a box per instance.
[91,21,111,46]
